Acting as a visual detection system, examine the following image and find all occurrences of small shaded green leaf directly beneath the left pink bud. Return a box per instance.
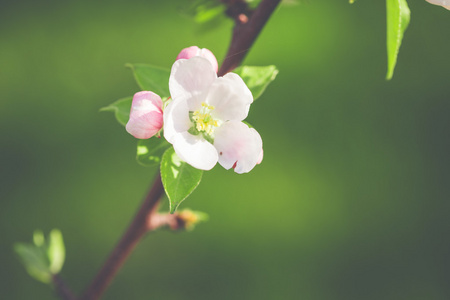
[136,137,170,167]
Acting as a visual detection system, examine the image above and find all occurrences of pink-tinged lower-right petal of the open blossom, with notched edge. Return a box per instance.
[214,121,262,174]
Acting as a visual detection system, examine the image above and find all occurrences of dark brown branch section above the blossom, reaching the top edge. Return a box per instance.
[218,0,281,76]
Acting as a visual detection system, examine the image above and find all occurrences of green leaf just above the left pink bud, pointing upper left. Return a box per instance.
[126,64,170,98]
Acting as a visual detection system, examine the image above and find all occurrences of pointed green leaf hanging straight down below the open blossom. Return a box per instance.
[161,147,203,214]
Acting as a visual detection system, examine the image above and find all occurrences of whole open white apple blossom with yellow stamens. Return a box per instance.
[164,56,262,173]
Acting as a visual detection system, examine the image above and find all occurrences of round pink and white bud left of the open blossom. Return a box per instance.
[125,91,163,139]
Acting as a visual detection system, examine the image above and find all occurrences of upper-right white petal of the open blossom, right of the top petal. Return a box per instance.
[206,73,253,121]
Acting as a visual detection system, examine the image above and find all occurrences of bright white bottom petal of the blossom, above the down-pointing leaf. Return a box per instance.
[173,132,218,171]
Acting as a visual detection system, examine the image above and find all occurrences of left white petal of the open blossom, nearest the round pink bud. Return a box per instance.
[164,100,191,144]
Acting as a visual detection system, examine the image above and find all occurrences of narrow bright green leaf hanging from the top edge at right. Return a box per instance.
[386,0,410,80]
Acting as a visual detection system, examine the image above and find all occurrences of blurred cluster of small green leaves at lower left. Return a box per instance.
[14,229,65,283]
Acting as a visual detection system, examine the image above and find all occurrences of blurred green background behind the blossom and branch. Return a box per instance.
[0,0,450,300]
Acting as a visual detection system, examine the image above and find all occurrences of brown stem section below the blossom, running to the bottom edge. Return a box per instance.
[82,174,164,300]
